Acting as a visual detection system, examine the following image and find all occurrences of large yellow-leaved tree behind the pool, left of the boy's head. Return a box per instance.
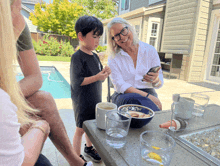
[29,0,84,38]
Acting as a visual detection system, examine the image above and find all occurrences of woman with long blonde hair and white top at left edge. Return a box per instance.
[0,0,50,166]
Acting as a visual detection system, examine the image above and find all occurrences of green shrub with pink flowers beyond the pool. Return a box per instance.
[32,34,74,57]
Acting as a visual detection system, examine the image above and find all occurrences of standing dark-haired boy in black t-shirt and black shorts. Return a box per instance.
[70,16,111,162]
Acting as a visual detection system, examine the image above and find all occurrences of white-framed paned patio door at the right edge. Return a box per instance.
[207,17,220,82]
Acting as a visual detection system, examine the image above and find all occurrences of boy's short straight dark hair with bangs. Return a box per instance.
[75,15,103,36]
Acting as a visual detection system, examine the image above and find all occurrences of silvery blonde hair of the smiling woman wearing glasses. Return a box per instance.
[107,17,139,57]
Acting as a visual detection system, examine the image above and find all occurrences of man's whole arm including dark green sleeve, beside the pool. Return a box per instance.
[17,24,43,97]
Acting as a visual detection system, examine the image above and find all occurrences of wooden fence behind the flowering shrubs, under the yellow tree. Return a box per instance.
[31,32,79,48]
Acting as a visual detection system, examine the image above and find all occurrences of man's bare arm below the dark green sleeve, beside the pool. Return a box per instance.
[18,48,43,97]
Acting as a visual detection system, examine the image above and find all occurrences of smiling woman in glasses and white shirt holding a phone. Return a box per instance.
[107,17,163,114]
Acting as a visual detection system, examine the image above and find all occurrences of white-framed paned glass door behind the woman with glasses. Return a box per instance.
[146,17,160,50]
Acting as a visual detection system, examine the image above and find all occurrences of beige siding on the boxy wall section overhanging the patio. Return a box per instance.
[161,0,197,54]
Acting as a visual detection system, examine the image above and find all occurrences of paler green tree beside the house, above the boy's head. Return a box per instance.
[72,0,117,19]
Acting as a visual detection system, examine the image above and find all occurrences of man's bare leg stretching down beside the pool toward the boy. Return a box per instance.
[27,91,84,165]
